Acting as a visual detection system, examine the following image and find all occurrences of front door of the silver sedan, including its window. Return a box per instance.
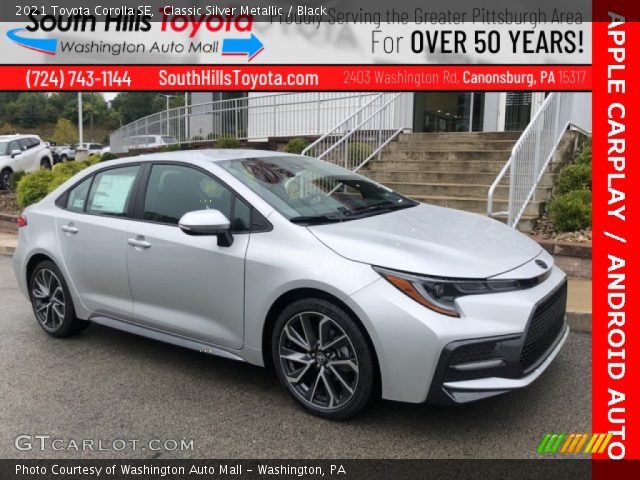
[127,163,251,348]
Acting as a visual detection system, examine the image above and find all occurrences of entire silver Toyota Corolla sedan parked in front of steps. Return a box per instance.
[13,150,569,419]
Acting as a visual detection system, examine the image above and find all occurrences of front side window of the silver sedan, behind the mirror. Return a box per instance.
[143,164,251,232]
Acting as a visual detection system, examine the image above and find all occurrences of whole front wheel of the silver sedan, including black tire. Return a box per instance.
[271,298,377,420]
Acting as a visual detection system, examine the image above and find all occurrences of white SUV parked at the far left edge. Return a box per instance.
[0,135,53,190]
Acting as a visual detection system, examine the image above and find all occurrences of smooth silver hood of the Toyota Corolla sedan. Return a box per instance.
[308,204,542,278]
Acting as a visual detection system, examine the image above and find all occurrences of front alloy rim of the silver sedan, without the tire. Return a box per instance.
[278,312,360,410]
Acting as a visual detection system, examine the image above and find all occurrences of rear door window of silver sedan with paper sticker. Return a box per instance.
[87,165,140,216]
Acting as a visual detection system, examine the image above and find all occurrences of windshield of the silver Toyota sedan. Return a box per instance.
[218,156,417,224]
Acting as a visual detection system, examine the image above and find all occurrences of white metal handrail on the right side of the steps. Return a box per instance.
[487,92,591,228]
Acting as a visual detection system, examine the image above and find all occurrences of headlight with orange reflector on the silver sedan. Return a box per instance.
[373,267,524,317]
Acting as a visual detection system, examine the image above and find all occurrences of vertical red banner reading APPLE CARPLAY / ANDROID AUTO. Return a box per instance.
[592,1,640,472]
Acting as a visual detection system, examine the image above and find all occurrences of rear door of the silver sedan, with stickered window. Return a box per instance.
[56,165,140,319]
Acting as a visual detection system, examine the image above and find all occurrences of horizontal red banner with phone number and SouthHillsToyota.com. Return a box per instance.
[0,65,591,91]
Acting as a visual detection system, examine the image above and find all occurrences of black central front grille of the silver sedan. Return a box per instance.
[520,282,567,372]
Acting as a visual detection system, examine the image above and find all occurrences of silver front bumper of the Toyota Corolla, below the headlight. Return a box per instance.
[347,252,567,403]
